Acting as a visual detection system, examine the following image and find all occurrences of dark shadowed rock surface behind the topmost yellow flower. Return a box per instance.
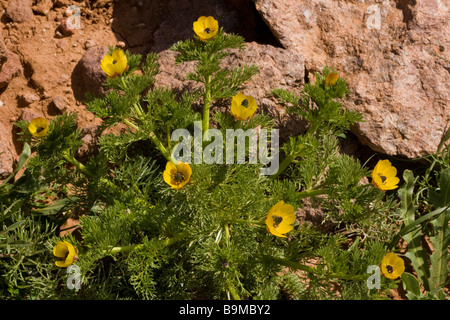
[112,0,280,54]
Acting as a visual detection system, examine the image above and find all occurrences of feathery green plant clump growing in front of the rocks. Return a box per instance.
[0,19,450,300]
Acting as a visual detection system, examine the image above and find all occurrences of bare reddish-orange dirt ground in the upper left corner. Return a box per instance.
[0,0,119,161]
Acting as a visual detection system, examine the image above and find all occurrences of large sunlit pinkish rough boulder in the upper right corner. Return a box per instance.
[253,0,450,158]
